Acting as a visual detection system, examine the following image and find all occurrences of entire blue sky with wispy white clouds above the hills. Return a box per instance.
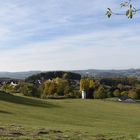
[0,0,140,72]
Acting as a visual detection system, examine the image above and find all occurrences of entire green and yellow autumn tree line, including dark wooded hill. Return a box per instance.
[1,72,140,99]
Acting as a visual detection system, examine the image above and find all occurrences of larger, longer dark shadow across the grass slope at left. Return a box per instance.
[0,92,60,108]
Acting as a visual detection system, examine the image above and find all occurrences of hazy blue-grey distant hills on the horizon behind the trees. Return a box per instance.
[0,69,140,79]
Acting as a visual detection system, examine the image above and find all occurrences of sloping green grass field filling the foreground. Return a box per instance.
[0,93,140,140]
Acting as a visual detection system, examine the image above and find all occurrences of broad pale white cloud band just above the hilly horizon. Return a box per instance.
[0,21,140,71]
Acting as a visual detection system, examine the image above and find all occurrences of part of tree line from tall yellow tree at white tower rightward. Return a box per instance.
[80,77,140,99]
